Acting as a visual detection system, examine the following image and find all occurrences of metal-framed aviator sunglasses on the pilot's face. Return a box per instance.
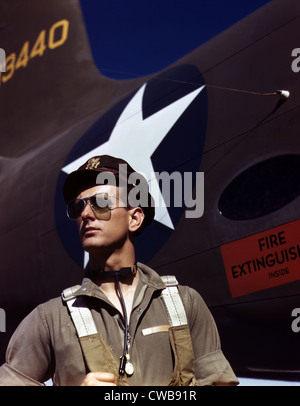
[67,193,123,220]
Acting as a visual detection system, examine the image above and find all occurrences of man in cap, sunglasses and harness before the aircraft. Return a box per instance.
[0,155,238,386]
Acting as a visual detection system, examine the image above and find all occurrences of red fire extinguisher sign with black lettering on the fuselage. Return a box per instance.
[221,220,300,297]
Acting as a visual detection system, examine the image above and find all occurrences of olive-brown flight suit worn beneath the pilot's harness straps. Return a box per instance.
[0,264,238,386]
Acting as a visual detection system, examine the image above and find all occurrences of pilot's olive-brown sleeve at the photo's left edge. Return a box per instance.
[0,306,52,386]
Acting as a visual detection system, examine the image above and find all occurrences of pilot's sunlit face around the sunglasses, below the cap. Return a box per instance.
[77,185,141,254]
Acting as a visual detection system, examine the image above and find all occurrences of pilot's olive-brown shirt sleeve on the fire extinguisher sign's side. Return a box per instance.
[178,287,239,386]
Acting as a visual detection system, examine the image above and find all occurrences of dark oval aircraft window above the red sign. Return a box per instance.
[218,154,300,220]
